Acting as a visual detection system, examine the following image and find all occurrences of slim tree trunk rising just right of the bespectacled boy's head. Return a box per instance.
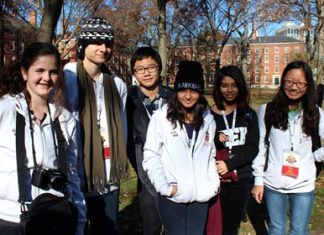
[157,0,168,85]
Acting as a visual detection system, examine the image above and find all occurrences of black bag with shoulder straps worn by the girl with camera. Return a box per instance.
[16,113,78,235]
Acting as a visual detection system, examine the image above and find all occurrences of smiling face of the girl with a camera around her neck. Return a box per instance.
[21,55,59,100]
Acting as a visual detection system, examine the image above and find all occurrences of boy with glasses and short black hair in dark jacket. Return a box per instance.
[126,47,172,235]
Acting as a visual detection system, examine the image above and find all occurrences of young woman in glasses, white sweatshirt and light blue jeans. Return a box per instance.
[252,61,324,235]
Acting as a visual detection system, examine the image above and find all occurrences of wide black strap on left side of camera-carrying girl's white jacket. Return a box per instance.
[16,112,27,202]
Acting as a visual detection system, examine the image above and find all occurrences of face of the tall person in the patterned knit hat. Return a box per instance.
[83,42,112,65]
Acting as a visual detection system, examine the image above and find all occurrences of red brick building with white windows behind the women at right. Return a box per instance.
[168,36,304,88]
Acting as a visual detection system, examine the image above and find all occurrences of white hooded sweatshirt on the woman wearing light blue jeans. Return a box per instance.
[252,104,324,193]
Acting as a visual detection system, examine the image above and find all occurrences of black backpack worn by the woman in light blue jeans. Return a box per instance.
[263,103,323,177]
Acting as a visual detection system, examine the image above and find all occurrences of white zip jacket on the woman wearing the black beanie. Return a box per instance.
[143,105,220,203]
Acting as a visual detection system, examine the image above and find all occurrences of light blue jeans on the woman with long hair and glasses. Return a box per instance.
[265,187,314,235]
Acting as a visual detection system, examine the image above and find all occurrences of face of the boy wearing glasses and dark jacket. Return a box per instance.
[134,57,160,89]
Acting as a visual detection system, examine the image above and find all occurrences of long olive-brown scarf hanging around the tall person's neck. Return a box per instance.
[77,61,127,192]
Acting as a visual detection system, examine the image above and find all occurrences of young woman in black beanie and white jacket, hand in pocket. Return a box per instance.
[143,61,219,235]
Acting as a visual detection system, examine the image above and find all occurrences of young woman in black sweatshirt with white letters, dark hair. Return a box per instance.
[207,66,259,235]
